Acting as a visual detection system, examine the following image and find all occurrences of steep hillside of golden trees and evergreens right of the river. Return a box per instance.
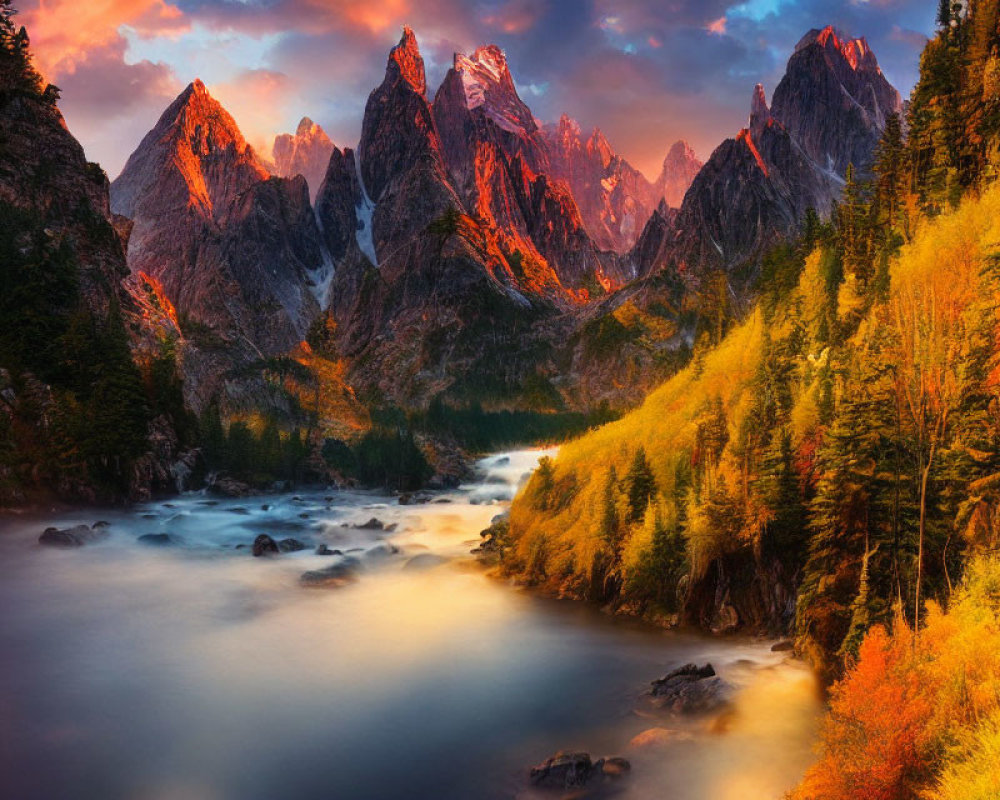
[504,0,1000,677]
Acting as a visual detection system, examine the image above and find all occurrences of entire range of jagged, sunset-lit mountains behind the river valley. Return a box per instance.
[101,23,901,418]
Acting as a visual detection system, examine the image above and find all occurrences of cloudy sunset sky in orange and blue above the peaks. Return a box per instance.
[15,0,938,178]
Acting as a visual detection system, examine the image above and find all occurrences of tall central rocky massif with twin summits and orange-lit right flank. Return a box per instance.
[317,29,579,405]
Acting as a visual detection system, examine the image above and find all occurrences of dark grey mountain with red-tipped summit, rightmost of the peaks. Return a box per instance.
[633,28,901,276]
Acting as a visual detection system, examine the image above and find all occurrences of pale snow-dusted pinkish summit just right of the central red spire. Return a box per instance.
[453,44,538,136]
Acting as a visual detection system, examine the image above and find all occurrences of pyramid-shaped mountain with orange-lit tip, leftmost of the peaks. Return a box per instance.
[111,81,330,408]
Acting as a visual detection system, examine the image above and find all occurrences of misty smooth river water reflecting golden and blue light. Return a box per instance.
[0,452,818,800]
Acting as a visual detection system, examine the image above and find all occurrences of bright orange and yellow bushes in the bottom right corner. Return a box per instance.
[791,558,1000,800]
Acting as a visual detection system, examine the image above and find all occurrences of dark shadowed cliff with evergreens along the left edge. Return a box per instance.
[0,46,193,500]
